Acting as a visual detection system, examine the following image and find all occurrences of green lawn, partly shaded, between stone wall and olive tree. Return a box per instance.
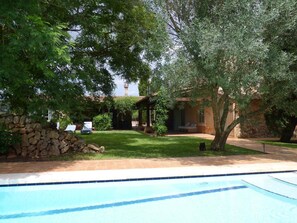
[54,131,260,160]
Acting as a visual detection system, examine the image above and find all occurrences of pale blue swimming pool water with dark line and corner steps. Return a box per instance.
[0,173,297,223]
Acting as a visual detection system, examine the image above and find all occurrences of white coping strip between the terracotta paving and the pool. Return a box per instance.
[0,164,297,185]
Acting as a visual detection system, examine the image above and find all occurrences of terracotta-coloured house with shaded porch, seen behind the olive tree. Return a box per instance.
[136,95,271,138]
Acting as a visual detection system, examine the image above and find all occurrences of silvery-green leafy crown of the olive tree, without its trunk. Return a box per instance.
[158,0,297,106]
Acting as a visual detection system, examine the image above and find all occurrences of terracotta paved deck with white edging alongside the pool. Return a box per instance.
[0,134,297,185]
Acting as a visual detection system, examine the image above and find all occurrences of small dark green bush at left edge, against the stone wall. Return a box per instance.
[0,124,20,155]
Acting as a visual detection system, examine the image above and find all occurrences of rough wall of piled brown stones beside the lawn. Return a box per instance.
[0,115,104,159]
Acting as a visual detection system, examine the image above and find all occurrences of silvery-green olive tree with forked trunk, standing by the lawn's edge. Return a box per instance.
[156,0,297,150]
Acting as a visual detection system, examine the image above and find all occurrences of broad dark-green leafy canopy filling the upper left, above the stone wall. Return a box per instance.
[0,0,162,116]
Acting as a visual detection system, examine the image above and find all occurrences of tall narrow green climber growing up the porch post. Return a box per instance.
[154,88,169,136]
